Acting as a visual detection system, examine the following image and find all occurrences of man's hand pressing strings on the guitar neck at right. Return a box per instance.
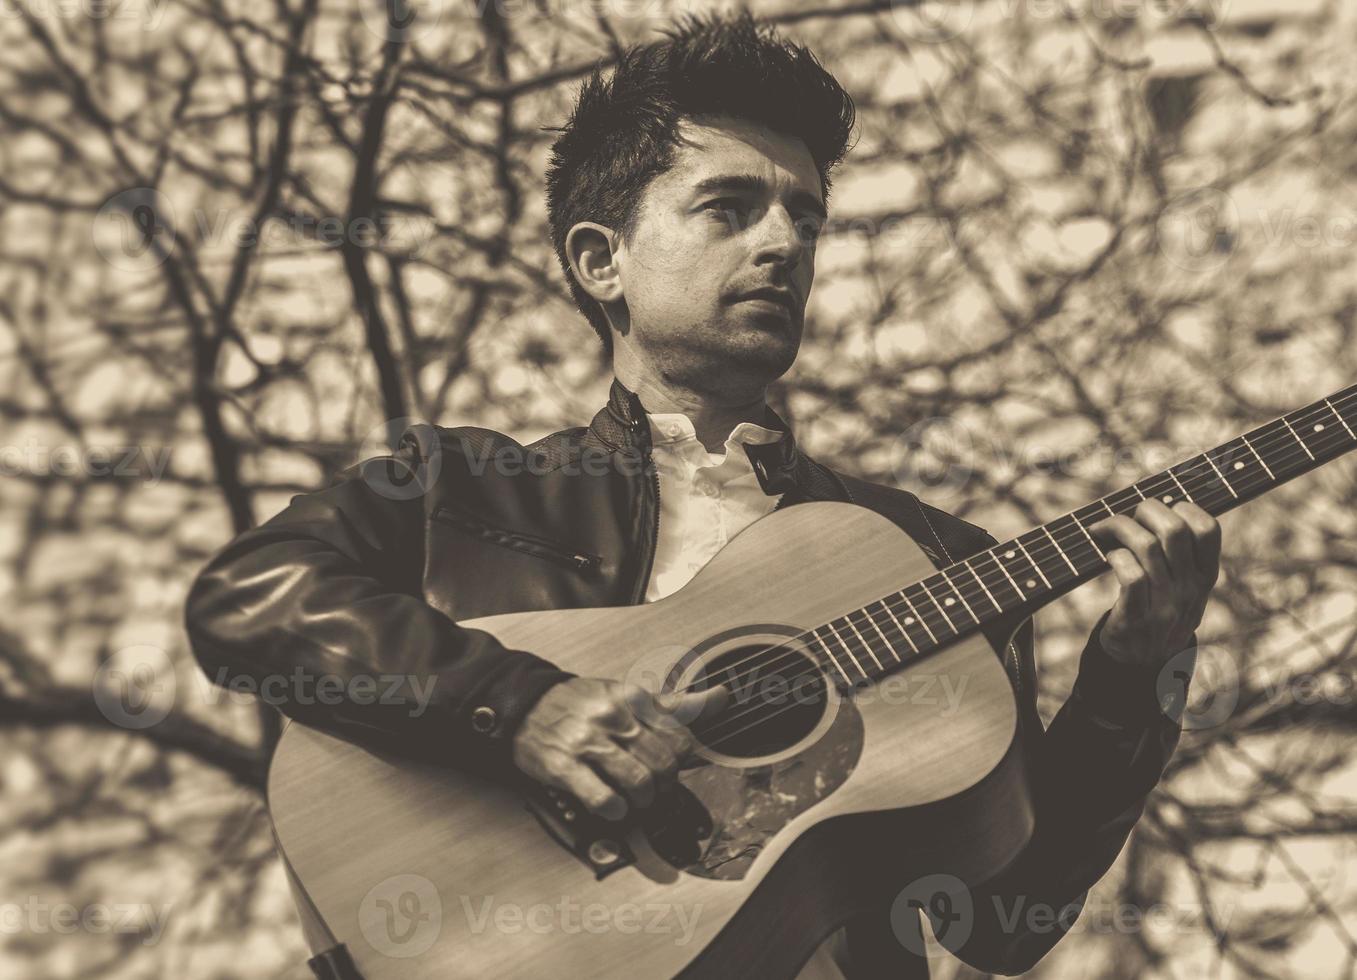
[1090,500,1220,664]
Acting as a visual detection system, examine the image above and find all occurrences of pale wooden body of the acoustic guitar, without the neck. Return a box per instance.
[269,502,1031,980]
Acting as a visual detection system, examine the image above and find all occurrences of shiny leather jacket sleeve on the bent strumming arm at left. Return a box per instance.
[185,425,573,772]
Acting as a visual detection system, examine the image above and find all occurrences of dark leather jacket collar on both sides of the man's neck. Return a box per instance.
[589,379,847,500]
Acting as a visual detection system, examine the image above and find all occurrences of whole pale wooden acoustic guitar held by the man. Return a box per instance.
[269,385,1357,980]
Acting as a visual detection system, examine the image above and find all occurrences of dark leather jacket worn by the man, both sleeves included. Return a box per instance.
[187,383,1179,980]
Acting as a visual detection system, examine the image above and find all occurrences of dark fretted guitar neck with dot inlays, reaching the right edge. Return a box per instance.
[809,385,1357,685]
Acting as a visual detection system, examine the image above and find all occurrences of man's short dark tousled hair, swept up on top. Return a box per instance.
[547,11,855,350]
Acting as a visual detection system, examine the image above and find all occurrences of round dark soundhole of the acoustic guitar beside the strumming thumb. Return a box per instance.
[692,645,828,759]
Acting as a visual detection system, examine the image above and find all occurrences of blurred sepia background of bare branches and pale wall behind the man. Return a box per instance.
[0,0,1357,979]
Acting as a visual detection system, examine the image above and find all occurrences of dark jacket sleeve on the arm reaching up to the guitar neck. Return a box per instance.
[954,602,1197,975]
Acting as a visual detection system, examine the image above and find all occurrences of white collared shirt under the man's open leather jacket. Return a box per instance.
[646,413,782,603]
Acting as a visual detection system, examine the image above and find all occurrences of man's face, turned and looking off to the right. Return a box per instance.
[613,117,825,392]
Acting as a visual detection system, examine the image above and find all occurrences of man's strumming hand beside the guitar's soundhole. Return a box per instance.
[513,677,729,820]
